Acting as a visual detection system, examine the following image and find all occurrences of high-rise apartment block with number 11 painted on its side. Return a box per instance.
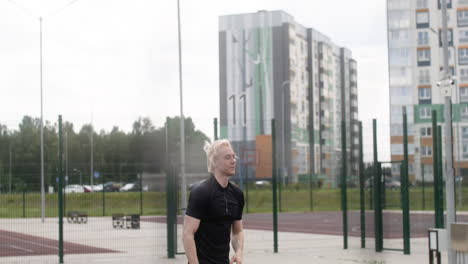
[219,11,359,187]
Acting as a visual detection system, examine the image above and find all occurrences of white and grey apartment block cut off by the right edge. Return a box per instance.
[387,0,468,182]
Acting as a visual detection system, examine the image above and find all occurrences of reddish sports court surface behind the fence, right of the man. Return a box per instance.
[148,211,468,238]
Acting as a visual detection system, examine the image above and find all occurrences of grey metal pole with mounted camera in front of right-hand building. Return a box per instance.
[441,0,456,264]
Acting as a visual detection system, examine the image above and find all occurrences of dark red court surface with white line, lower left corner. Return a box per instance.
[0,230,118,262]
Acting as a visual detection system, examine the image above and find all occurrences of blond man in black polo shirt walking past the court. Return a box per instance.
[183,139,244,264]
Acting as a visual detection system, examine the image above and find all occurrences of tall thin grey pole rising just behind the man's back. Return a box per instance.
[177,0,187,214]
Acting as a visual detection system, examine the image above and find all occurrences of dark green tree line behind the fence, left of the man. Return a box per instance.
[0,116,209,192]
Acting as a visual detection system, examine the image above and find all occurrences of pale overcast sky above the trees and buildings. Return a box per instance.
[0,0,390,160]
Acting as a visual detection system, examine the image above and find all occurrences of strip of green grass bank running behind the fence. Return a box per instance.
[0,185,468,218]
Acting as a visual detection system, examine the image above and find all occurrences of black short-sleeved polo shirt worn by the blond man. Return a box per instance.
[186,175,244,264]
